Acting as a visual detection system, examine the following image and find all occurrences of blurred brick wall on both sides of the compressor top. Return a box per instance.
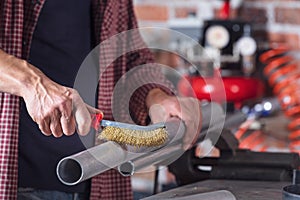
[134,0,300,51]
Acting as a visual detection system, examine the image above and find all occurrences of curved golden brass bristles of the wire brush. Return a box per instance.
[99,126,168,147]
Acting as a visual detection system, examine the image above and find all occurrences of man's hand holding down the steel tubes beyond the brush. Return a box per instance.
[146,89,202,149]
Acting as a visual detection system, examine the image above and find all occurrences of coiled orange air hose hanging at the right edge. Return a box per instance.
[259,46,300,153]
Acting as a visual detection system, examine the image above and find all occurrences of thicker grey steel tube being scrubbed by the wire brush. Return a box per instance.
[56,119,183,185]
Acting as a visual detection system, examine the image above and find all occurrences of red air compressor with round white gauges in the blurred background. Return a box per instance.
[178,0,264,108]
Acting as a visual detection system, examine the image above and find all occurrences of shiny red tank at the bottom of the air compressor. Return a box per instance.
[178,71,264,107]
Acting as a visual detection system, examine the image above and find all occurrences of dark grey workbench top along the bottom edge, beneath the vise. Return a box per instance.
[143,180,291,200]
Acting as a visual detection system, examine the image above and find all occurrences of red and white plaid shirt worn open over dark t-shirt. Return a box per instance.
[0,0,170,200]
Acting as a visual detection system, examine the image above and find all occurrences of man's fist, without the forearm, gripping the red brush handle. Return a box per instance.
[23,81,101,137]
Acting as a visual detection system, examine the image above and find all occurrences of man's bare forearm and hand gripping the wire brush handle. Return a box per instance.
[0,49,101,137]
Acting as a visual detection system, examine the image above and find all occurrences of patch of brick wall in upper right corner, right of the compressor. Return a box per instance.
[239,0,300,51]
